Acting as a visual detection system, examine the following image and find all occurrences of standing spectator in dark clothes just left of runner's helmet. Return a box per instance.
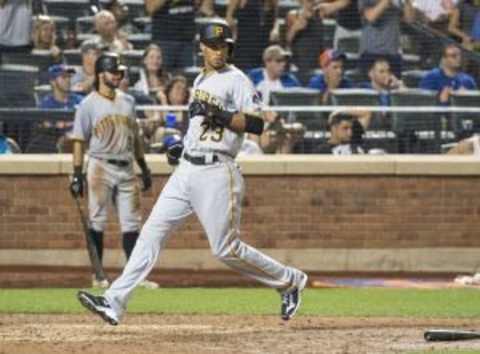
[145,0,195,71]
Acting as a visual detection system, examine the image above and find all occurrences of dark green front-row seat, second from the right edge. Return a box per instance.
[390,89,442,153]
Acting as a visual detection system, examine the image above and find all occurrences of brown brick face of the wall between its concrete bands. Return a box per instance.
[0,174,480,249]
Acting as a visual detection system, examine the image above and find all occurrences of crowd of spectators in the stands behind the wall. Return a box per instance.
[0,0,480,153]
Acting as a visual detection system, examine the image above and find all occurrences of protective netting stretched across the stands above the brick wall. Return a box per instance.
[0,0,480,153]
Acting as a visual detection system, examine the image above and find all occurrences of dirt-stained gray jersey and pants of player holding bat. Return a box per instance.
[73,90,141,232]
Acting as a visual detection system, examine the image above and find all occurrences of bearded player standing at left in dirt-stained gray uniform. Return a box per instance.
[70,53,158,288]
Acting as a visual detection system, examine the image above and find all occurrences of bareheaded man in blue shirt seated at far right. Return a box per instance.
[420,44,477,104]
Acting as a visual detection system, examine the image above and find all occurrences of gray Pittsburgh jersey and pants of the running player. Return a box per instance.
[105,66,306,318]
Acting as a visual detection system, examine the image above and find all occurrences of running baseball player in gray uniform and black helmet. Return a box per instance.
[77,20,307,325]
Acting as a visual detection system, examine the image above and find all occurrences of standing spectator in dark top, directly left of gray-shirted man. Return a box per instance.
[318,0,362,49]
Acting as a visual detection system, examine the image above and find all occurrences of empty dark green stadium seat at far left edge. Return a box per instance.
[0,64,39,107]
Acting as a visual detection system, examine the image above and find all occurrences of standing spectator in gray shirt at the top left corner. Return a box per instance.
[0,0,32,61]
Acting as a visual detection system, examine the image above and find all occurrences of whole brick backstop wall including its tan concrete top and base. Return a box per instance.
[0,155,480,272]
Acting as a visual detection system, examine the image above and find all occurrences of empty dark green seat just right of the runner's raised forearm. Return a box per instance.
[270,87,322,131]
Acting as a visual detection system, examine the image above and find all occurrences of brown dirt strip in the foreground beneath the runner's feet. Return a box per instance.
[0,315,480,354]
